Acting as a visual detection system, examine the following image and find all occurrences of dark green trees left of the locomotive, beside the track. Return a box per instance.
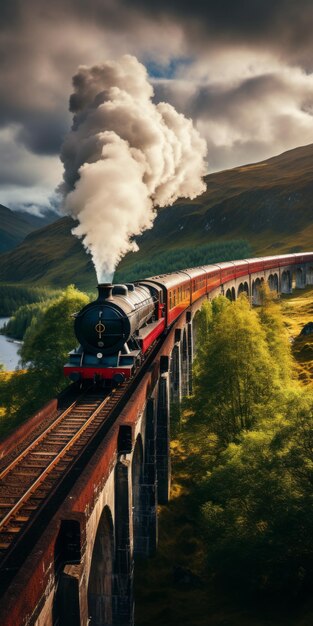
[0,286,89,432]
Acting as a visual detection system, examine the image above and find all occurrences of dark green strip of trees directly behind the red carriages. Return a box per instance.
[114,239,252,282]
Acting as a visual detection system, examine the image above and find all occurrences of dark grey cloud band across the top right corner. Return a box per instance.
[121,0,313,56]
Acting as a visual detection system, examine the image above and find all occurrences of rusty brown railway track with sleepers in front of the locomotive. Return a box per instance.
[0,385,127,567]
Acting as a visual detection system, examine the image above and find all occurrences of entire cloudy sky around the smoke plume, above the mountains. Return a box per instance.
[0,0,313,208]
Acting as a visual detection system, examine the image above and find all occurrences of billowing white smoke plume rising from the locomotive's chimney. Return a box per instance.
[61,55,207,282]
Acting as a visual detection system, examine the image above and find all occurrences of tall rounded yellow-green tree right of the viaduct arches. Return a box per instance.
[193,296,278,444]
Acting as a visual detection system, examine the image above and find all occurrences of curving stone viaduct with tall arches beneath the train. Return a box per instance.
[0,255,313,626]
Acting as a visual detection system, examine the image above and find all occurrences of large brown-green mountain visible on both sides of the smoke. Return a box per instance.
[0,145,313,289]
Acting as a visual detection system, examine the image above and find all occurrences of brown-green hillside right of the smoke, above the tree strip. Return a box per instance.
[121,145,313,276]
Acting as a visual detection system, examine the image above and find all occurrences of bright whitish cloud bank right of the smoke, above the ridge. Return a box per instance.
[155,66,313,171]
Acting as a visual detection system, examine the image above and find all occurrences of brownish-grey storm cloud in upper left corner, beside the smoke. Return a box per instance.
[0,0,149,166]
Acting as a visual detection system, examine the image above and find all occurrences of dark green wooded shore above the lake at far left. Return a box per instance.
[0,284,60,317]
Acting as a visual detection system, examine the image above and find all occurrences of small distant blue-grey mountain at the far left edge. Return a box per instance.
[0,204,56,252]
